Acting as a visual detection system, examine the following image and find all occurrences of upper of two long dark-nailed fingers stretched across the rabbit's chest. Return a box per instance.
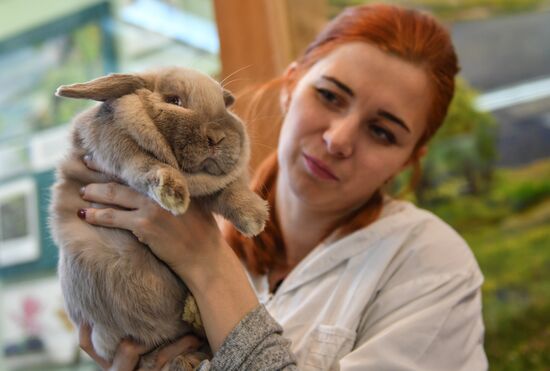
[80,182,145,209]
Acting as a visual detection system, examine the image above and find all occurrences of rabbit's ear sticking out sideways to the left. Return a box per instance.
[55,73,146,102]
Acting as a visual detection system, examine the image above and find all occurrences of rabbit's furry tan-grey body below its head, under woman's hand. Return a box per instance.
[51,147,191,359]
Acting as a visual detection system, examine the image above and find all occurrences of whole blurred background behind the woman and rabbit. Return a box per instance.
[0,0,550,370]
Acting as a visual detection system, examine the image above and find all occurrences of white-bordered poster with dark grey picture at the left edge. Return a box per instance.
[0,177,40,268]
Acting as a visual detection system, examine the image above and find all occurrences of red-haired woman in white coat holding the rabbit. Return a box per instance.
[76,5,487,370]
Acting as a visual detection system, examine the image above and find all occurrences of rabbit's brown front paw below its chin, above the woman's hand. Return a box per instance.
[150,169,189,215]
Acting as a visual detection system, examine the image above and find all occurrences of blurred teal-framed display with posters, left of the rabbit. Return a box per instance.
[0,0,118,370]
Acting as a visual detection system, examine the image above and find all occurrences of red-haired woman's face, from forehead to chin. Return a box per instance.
[279,42,430,213]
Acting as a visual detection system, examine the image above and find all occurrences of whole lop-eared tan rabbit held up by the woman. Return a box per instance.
[49,67,268,369]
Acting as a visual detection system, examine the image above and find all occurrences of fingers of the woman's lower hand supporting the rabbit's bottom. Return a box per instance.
[78,324,201,371]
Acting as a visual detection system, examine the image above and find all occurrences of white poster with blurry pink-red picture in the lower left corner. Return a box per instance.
[0,276,79,371]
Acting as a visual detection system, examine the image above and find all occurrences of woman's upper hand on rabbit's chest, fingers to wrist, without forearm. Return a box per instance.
[78,158,227,282]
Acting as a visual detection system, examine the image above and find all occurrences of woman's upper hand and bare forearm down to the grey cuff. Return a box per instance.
[80,158,264,352]
